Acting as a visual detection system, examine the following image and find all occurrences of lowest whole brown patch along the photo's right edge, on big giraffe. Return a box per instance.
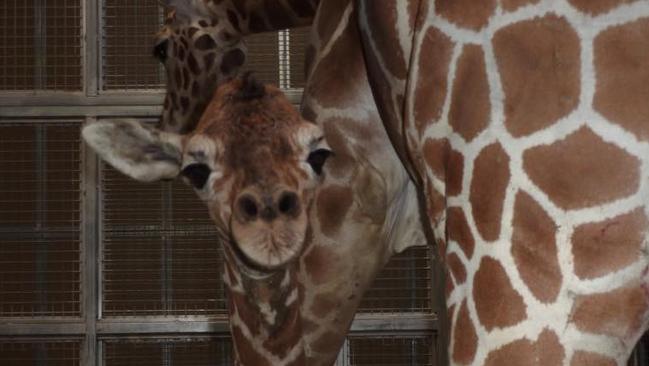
[571,286,649,338]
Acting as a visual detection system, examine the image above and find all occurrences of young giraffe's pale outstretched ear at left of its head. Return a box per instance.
[82,119,183,182]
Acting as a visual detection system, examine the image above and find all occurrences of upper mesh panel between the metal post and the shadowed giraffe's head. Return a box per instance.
[101,0,165,90]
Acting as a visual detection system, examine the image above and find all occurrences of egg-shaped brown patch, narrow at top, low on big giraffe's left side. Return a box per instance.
[473,257,527,331]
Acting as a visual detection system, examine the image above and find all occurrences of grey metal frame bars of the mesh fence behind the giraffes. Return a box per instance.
[0,0,437,366]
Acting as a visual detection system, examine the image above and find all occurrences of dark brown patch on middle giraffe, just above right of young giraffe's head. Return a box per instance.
[305,14,369,108]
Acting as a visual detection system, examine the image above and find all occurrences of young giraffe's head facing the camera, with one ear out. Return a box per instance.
[83,75,331,273]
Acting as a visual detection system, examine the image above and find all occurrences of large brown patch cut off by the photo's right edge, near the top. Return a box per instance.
[594,18,649,141]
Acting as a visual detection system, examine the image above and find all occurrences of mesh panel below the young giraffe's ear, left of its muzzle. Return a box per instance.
[102,165,226,316]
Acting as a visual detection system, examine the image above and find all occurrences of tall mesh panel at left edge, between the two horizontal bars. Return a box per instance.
[0,122,80,317]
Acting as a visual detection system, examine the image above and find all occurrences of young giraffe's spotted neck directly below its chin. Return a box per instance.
[223,246,306,366]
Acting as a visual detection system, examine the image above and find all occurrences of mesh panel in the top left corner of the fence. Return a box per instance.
[0,0,83,91]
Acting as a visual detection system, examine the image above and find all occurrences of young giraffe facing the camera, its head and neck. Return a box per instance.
[83,75,331,365]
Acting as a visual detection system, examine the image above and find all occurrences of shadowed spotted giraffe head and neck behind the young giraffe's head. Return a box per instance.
[160,0,319,133]
